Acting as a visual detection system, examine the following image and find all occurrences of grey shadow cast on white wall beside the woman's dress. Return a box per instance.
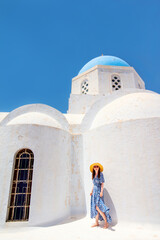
[104,188,118,226]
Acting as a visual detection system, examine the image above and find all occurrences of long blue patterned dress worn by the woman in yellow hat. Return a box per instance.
[90,172,112,223]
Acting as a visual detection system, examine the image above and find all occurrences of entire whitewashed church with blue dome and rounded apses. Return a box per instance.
[0,56,160,227]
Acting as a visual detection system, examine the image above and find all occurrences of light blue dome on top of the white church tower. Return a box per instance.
[78,56,130,75]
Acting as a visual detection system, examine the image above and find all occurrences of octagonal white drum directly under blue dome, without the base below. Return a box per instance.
[71,65,145,95]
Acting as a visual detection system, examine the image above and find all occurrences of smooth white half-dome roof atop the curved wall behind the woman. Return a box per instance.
[91,92,160,129]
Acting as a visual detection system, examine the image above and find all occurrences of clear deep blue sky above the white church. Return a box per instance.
[0,0,160,113]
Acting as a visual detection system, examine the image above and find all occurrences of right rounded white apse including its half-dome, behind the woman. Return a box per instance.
[82,92,160,224]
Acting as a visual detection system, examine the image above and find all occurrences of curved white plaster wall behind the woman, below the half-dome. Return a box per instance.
[83,118,160,224]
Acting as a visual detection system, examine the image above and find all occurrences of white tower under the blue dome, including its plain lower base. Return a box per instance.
[67,65,145,114]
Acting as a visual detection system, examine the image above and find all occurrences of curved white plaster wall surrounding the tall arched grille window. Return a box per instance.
[0,124,71,225]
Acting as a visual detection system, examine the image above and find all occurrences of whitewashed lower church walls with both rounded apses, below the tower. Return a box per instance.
[0,89,160,229]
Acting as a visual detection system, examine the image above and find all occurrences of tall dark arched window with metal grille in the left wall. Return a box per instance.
[7,149,34,221]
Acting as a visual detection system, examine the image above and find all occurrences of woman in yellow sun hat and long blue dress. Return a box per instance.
[90,163,112,228]
